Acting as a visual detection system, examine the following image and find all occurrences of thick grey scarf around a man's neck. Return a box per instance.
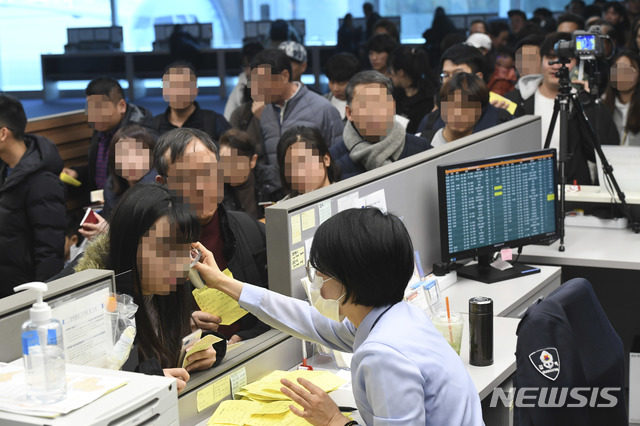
[342,121,406,170]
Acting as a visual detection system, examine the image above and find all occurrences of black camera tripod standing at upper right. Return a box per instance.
[544,58,640,251]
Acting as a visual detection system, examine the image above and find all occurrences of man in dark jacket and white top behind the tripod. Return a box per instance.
[505,33,620,185]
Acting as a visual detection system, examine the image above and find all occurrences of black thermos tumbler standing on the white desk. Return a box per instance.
[469,297,493,367]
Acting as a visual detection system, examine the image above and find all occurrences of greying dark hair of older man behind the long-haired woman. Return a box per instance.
[153,127,220,176]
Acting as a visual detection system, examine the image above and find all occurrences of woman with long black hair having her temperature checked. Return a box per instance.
[74,184,226,390]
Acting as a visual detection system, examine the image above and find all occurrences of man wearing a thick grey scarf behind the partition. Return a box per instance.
[329,71,431,179]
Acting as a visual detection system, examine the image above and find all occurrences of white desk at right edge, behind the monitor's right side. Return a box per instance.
[520,226,640,270]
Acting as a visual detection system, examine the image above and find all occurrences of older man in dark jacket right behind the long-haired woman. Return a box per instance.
[153,128,269,343]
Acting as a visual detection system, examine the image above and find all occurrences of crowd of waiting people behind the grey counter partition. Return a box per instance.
[0,0,640,420]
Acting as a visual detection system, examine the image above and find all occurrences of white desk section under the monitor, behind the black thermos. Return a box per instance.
[442,264,561,317]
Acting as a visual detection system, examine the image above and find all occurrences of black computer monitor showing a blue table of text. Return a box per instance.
[437,149,558,283]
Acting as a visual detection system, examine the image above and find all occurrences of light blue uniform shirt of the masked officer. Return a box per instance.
[239,284,483,426]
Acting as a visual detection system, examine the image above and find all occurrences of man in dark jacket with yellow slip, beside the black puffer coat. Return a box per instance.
[64,77,157,198]
